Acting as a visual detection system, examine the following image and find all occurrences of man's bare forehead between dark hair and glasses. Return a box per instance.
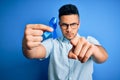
[60,14,79,23]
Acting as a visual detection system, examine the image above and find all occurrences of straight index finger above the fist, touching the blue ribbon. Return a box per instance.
[27,24,53,32]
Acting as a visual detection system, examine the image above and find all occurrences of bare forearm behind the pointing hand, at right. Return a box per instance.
[92,45,108,63]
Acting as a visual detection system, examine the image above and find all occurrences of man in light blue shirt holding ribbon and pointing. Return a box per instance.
[23,4,108,80]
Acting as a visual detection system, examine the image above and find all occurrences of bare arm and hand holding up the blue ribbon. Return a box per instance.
[22,24,52,59]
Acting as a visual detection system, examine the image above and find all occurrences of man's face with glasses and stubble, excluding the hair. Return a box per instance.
[59,14,80,40]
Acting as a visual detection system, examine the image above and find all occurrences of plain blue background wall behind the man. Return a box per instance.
[0,0,120,80]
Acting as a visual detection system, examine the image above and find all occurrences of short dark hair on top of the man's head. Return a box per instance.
[59,4,79,19]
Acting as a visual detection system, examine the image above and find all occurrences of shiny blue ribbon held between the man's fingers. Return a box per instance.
[43,17,57,40]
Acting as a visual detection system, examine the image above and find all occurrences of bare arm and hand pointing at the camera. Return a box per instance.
[68,37,108,63]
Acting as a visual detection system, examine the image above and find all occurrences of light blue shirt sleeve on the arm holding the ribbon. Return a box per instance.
[41,38,53,58]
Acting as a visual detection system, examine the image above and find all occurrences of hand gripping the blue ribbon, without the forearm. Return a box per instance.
[23,24,53,49]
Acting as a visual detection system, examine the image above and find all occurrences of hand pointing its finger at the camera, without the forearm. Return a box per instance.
[68,36,97,63]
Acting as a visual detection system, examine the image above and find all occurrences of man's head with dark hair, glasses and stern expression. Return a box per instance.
[59,4,80,40]
